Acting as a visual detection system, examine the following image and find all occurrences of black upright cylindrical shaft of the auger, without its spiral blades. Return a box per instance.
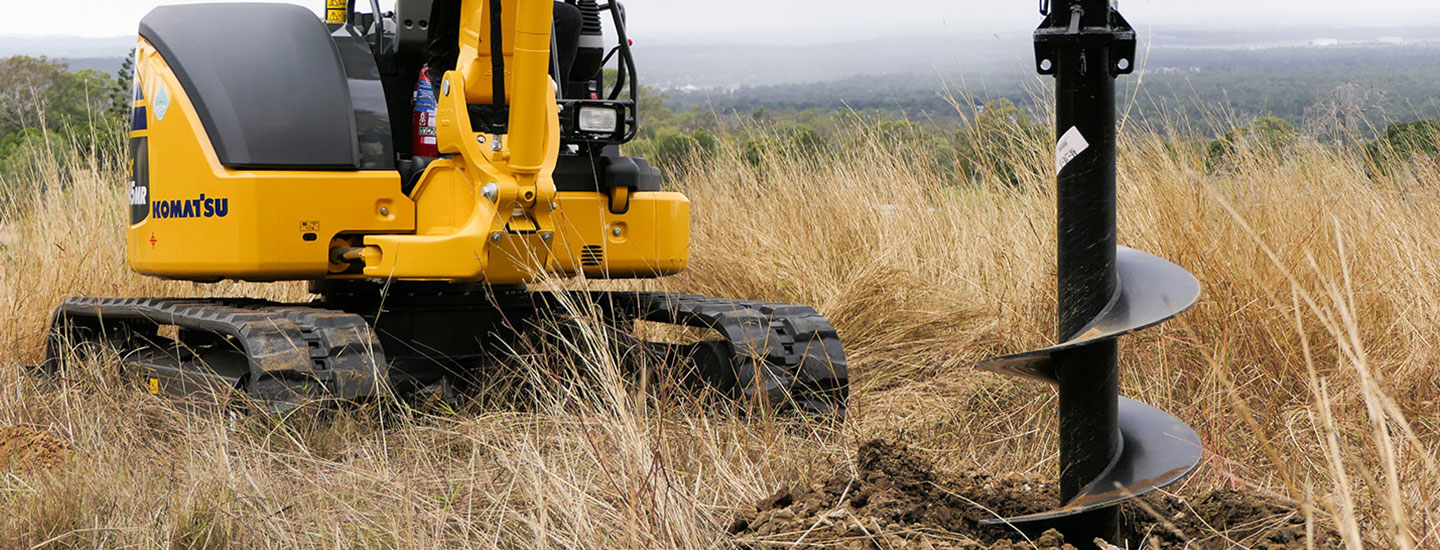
[1037,0,1130,544]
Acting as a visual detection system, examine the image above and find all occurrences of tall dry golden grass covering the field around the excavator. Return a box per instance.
[0,117,1440,549]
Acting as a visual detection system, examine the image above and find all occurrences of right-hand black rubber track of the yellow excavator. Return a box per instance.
[595,292,850,419]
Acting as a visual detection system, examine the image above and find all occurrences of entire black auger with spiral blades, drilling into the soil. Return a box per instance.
[981,0,1201,547]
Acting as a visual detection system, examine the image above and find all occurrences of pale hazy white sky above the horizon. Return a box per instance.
[8,0,1440,42]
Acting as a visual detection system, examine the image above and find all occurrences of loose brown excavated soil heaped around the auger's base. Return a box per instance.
[730,441,1339,550]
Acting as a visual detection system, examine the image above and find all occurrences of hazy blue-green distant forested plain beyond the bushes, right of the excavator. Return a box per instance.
[667,46,1440,144]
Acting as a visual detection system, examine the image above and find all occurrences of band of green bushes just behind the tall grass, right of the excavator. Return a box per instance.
[632,81,1440,186]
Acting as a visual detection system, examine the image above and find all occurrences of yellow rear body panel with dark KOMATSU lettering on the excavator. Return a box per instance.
[125,33,415,281]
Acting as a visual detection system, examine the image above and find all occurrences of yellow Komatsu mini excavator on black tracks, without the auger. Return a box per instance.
[46,0,848,418]
